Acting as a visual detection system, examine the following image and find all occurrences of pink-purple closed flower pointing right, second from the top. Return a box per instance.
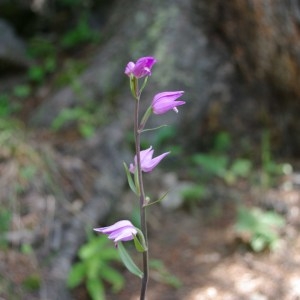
[152,91,185,115]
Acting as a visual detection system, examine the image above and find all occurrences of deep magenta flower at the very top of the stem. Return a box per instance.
[125,56,156,78]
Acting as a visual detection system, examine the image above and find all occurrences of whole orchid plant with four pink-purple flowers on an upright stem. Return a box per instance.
[94,56,185,300]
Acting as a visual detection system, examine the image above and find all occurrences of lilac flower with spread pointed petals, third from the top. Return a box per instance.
[129,146,170,173]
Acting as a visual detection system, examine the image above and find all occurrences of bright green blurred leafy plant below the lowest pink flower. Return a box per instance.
[67,235,124,300]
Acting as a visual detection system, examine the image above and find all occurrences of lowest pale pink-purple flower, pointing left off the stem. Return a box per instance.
[94,220,137,244]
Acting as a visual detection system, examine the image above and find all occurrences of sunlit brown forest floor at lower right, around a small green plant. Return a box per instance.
[103,176,300,300]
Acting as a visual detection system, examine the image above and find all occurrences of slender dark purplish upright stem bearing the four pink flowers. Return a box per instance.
[134,82,149,300]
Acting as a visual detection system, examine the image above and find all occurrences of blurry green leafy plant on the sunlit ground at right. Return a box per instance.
[235,207,285,252]
